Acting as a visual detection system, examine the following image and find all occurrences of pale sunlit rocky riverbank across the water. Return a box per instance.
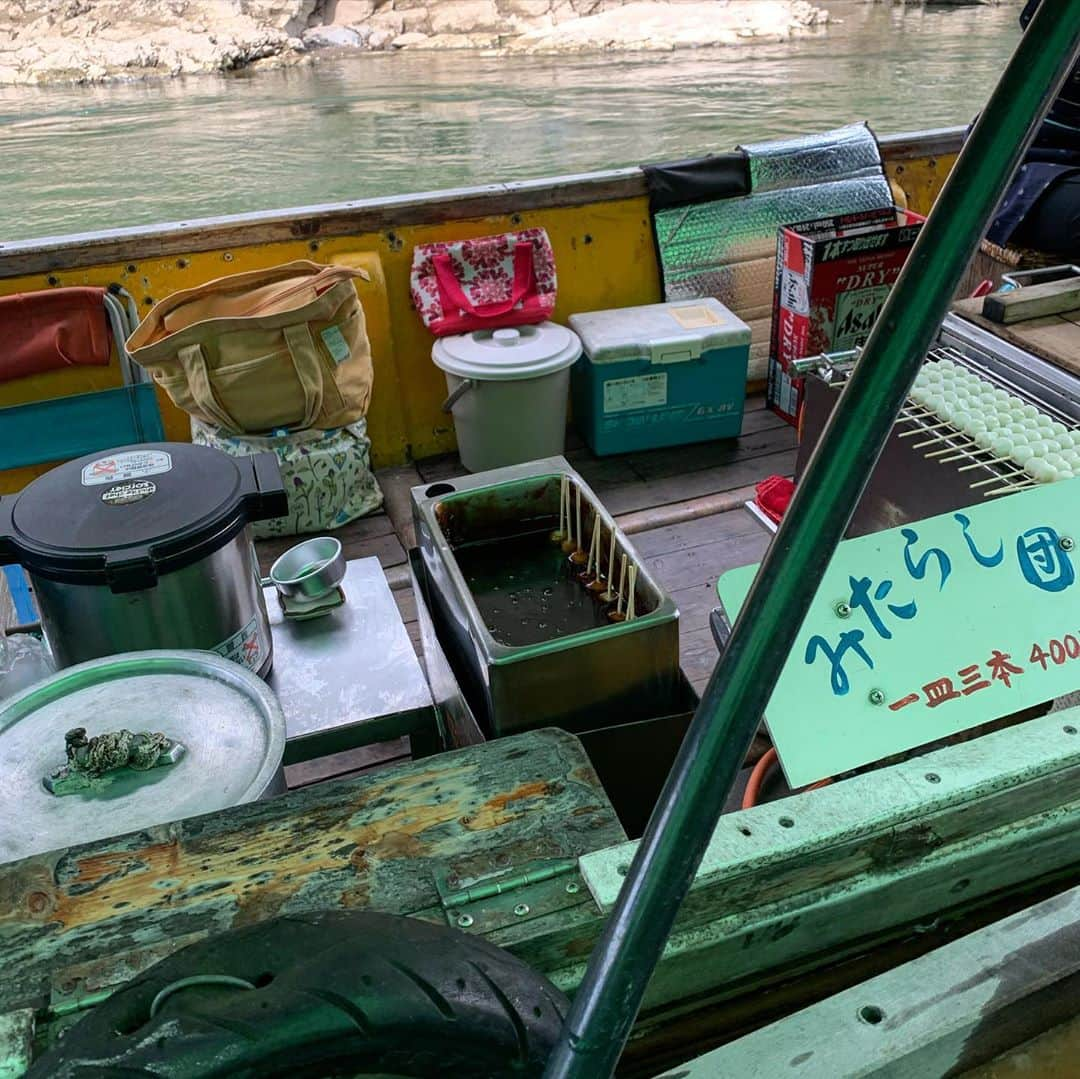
[0,0,828,84]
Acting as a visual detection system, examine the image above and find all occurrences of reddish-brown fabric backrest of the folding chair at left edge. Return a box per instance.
[0,288,112,381]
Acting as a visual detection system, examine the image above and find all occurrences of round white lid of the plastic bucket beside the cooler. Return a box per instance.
[431,322,581,381]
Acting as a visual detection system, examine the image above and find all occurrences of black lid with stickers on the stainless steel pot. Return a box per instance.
[0,442,287,592]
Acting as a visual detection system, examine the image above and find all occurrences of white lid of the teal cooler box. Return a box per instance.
[570,297,750,363]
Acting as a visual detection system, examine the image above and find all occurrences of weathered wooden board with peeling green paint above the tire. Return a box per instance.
[0,730,625,1012]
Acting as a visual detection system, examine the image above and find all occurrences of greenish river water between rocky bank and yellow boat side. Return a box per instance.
[0,0,1021,242]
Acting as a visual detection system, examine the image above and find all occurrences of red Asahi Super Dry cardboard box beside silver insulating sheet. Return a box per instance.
[767,206,926,426]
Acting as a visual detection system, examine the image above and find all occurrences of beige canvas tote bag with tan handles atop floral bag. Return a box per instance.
[127,260,373,434]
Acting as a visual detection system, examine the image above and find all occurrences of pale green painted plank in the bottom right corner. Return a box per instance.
[661,889,1080,1079]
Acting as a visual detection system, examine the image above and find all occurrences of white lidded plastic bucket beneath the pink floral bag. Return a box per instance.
[432,322,581,472]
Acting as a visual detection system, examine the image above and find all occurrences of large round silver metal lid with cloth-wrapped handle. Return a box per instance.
[0,651,285,862]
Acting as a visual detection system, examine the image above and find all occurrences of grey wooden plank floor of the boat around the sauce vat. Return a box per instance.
[258,395,796,704]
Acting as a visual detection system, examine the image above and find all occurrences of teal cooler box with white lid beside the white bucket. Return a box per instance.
[570,299,750,456]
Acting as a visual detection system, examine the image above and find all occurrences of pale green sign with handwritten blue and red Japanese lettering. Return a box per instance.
[717,478,1080,787]
